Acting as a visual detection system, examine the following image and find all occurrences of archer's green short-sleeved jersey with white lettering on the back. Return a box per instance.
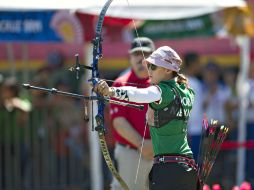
[147,80,195,156]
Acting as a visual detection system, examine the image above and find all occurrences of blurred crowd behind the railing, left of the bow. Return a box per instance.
[0,52,90,190]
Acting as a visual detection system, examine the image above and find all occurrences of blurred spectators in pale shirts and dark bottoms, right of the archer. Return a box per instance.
[184,52,254,189]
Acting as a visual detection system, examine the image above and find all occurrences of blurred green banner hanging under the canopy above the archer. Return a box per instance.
[138,15,215,39]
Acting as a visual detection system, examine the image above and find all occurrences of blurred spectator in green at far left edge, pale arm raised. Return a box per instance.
[0,77,31,188]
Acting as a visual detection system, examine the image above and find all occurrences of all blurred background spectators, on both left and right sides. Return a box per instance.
[0,52,254,189]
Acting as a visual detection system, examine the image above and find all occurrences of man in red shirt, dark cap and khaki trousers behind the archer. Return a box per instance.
[110,37,155,190]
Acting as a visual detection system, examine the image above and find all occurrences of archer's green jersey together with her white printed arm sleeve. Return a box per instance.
[110,79,195,157]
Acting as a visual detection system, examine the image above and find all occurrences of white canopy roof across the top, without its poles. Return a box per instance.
[0,0,246,20]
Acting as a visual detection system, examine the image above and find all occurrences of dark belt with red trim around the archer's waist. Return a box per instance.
[153,156,198,170]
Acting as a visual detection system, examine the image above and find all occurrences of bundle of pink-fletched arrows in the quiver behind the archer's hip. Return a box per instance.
[198,116,228,186]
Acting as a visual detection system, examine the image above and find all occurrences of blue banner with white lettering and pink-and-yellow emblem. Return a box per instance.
[0,11,83,43]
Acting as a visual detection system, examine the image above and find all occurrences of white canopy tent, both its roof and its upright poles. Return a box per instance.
[0,0,250,190]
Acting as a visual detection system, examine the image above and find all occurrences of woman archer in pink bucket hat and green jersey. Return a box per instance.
[94,46,198,190]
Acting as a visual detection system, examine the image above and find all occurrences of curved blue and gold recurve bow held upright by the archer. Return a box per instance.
[91,0,129,190]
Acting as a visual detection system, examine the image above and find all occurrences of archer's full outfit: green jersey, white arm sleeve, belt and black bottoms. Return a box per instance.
[114,79,199,190]
